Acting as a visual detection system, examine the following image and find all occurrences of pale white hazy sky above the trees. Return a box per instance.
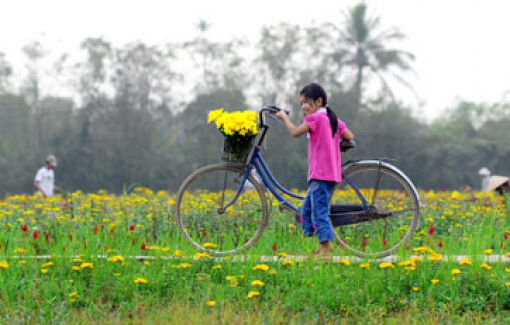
[0,0,510,118]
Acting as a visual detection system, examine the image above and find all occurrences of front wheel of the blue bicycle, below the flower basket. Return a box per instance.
[176,164,269,254]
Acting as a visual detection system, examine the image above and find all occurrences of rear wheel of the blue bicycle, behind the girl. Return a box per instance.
[330,160,420,258]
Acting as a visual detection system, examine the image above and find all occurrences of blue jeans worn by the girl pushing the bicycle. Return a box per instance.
[300,179,336,243]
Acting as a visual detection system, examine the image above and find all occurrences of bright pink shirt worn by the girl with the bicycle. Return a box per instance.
[304,108,347,182]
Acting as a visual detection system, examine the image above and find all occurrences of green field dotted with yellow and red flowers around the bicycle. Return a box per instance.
[0,188,510,322]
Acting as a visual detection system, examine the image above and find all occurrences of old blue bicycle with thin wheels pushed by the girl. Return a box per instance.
[176,106,422,258]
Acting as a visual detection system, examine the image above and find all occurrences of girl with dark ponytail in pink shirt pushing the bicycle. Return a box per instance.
[276,83,354,259]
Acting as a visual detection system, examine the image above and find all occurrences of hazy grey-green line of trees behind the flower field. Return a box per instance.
[0,3,510,195]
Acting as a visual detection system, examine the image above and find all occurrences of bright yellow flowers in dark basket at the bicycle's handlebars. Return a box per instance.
[207,108,258,162]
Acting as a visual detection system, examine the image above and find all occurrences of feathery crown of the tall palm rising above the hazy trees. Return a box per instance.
[333,3,414,110]
